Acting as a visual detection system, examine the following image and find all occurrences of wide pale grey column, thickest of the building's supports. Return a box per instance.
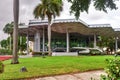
[34,31,40,52]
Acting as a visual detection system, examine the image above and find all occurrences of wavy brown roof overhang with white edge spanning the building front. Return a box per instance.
[19,19,115,36]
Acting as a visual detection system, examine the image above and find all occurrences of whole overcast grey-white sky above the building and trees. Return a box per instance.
[0,0,120,40]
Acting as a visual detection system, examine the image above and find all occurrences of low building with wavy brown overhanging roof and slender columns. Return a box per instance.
[19,19,120,52]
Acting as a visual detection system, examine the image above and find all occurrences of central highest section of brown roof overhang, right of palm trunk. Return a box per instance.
[51,19,89,34]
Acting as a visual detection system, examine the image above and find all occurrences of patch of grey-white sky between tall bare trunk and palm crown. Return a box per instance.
[19,0,40,24]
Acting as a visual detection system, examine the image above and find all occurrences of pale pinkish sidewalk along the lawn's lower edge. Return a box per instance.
[31,70,106,80]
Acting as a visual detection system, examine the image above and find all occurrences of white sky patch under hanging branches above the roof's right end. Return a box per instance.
[81,1,120,28]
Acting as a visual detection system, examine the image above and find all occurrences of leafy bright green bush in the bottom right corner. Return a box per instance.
[101,58,120,80]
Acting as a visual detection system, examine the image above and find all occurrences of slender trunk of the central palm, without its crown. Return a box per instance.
[48,20,52,56]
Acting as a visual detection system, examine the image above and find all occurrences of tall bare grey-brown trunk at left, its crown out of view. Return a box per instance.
[11,0,19,64]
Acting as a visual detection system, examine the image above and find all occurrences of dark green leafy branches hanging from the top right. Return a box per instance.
[68,0,118,19]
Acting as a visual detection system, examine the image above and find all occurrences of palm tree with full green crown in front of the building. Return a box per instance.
[33,0,63,55]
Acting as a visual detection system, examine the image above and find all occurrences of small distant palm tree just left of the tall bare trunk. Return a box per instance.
[3,22,14,50]
